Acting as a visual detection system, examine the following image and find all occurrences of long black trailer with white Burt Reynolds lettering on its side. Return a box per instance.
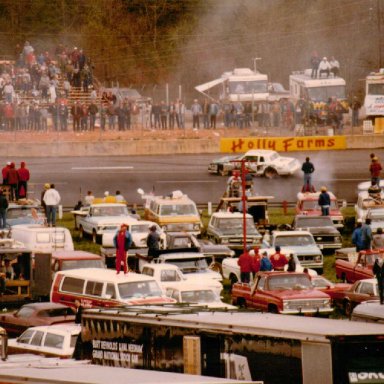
[81,305,384,384]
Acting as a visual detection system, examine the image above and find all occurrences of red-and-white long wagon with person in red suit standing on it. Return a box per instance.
[50,268,176,308]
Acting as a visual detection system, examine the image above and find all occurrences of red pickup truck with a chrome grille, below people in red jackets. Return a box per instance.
[232,272,332,314]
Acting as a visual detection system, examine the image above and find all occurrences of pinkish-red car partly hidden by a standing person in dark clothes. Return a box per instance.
[296,191,344,228]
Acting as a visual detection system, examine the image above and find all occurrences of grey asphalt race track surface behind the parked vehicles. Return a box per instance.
[0,149,372,207]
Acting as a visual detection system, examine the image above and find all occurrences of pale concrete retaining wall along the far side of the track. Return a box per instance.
[0,135,384,158]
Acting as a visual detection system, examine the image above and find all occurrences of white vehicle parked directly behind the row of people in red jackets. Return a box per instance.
[263,231,324,275]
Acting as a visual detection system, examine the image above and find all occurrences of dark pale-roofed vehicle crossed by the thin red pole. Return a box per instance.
[207,212,261,251]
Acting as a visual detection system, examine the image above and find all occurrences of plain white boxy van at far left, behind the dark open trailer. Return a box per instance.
[11,224,75,253]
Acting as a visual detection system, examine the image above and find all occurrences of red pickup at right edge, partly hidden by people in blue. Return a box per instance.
[335,249,384,283]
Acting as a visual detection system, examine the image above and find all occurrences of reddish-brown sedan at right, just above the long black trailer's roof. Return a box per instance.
[334,278,379,316]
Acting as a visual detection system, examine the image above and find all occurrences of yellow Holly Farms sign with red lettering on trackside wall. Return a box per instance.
[220,136,347,153]
